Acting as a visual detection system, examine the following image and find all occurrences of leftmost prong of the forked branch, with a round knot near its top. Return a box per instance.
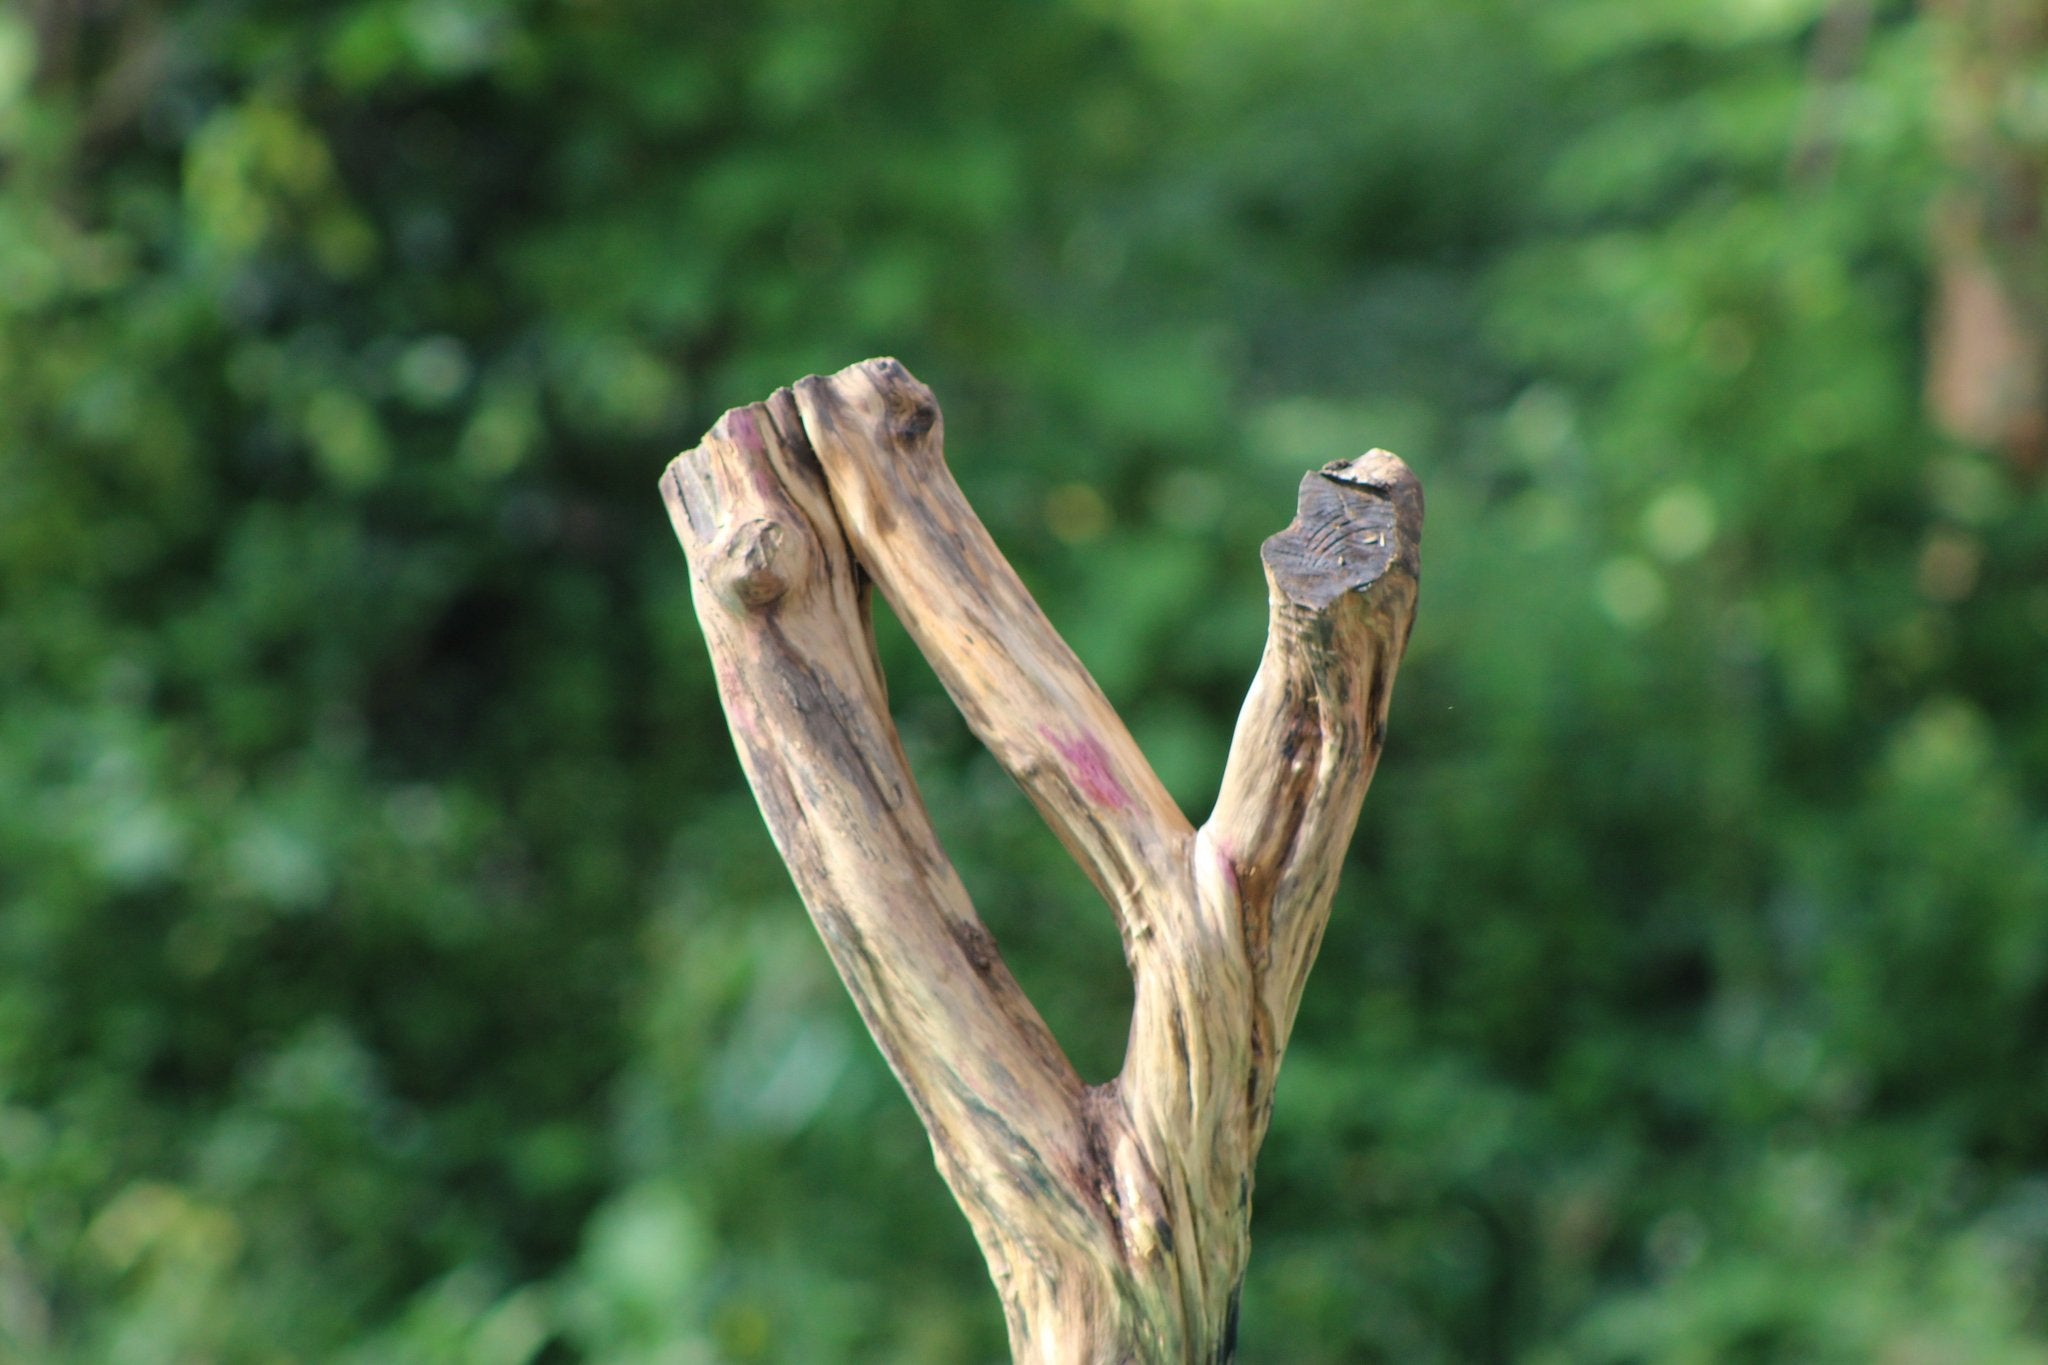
[664,391,1090,1326]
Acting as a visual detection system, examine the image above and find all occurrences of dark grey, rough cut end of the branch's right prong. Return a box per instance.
[1260,450,1421,612]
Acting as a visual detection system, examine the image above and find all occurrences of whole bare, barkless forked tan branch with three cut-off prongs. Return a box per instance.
[662,360,1421,1365]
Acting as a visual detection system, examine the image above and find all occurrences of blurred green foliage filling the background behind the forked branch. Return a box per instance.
[0,0,2048,1365]
